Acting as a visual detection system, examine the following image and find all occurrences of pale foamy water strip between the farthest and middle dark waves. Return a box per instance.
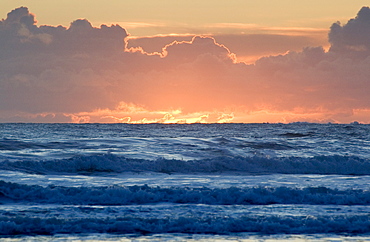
[0,171,370,190]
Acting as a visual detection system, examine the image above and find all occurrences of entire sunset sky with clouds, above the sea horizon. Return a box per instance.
[0,0,370,123]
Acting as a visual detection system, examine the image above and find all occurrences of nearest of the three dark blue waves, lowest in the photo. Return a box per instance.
[0,211,370,235]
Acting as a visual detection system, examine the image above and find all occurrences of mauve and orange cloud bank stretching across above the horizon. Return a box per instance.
[0,7,370,123]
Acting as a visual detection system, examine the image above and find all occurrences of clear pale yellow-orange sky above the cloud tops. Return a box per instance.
[0,0,368,33]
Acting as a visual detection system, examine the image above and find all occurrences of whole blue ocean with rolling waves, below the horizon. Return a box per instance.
[0,123,370,241]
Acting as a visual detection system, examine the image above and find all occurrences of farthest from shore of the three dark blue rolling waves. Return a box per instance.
[0,154,370,175]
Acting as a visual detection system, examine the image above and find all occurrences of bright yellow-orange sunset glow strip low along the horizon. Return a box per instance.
[57,102,370,124]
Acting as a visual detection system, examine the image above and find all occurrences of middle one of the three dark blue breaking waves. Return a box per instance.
[0,181,370,205]
